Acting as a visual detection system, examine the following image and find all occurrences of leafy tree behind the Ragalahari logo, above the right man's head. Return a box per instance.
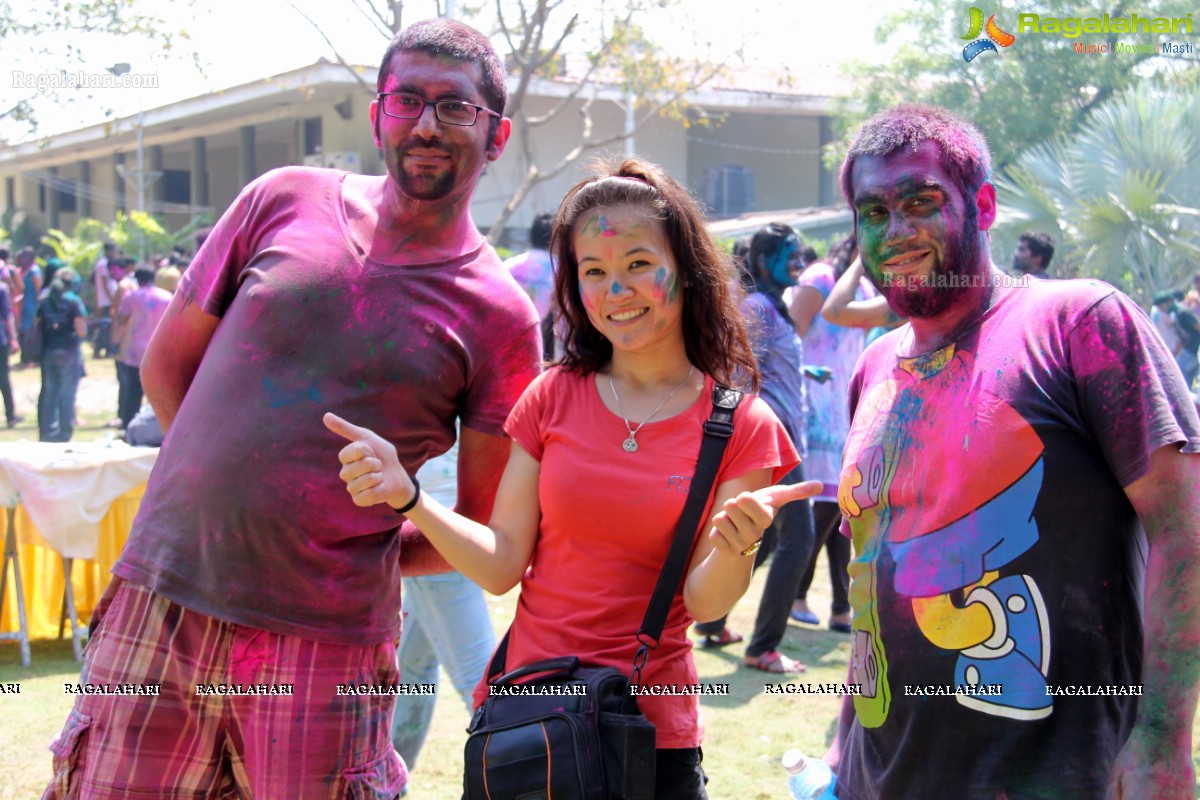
[828,0,1200,168]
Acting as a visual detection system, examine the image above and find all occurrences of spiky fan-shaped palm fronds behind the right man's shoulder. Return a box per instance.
[995,86,1200,305]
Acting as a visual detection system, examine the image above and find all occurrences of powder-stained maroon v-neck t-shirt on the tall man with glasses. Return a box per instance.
[113,168,541,644]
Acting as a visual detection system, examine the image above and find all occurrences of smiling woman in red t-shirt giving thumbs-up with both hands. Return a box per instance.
[325,160,820,800]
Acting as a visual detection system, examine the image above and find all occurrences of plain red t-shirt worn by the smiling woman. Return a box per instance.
[475,367,799,748]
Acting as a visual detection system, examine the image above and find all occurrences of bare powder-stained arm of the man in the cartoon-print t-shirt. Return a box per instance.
[1112,445,1200,800]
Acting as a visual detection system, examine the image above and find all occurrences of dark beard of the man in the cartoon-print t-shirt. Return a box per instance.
[876,203,988,319]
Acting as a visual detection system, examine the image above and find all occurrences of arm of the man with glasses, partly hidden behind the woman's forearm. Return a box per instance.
[398,424,512,576]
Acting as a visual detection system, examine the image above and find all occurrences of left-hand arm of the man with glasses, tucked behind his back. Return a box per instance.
[142,293,221,432]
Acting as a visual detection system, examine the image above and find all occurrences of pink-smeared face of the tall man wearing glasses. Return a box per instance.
[371,52,506,200]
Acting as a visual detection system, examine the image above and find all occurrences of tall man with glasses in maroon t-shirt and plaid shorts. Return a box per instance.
[46,19,540,800]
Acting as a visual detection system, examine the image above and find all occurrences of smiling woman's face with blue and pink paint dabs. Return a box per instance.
[574,205,683,351]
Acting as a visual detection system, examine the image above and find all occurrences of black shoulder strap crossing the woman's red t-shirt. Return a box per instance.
[487,385,742,684]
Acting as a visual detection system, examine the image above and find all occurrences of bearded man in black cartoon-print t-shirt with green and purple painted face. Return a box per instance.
[827,106,1200,800]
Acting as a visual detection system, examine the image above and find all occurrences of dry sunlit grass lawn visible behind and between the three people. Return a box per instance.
[0,348,1200,800]
